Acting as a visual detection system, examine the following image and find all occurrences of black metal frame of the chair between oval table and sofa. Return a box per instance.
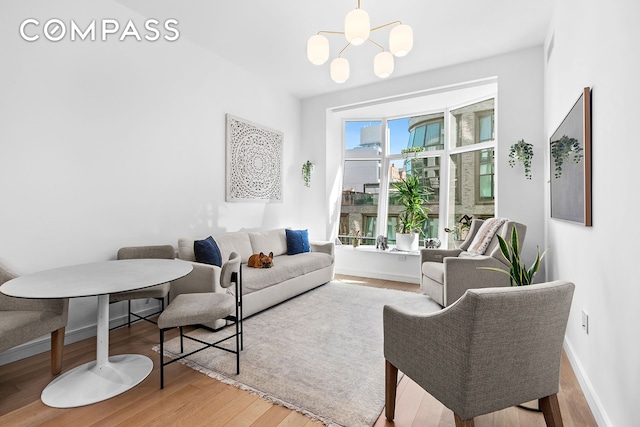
[160,264,244,389]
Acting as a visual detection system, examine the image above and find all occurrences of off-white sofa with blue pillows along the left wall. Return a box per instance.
[170,228,335,328]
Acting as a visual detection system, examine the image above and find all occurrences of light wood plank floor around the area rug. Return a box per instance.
[0,276,596,427]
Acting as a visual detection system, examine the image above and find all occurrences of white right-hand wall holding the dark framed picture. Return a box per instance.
[545,0,640,427]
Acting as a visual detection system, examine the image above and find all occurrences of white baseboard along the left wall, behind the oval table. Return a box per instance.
[0,307,158,366]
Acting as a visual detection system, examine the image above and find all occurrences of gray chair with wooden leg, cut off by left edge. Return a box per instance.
[0,264,69,375]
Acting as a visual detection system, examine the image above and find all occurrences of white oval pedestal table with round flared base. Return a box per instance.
[0,259,193,408]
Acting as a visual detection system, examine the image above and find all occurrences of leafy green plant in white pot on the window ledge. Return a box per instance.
[393,176,429,251]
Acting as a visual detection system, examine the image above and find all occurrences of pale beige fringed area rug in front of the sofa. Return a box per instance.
[154,281,440,427]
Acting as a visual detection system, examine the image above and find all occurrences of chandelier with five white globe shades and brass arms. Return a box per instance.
[307,0,413,83]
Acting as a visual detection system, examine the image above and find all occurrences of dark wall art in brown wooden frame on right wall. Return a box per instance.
[549,87,591,227]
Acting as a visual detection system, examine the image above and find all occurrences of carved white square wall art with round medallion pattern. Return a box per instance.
[226,114,283,202]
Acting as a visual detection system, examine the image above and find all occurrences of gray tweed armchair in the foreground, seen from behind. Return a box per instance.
[384,281,574,427]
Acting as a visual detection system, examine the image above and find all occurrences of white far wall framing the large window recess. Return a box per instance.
[302,47,545,276]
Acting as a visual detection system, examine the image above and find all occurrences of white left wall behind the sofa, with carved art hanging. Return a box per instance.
[0,0,304,362]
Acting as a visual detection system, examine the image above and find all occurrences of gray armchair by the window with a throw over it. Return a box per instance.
[420,219,527,307]
